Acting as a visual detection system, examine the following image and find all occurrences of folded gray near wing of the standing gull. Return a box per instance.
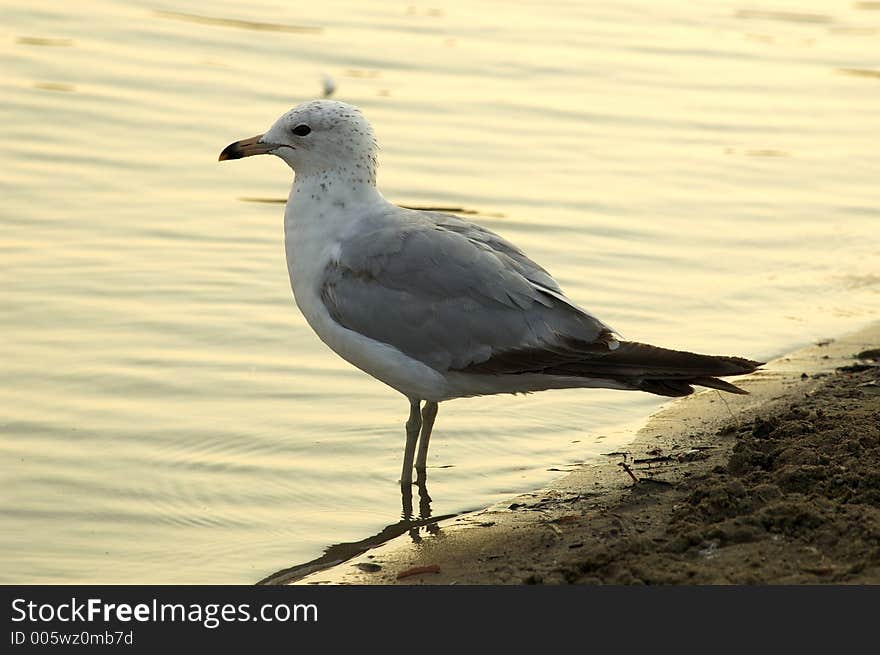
[321,209,614,373]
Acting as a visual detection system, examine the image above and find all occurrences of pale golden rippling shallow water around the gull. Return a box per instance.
[0,0,880,583]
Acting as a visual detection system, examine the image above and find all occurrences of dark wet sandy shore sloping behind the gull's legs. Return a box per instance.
[279,323,880,584]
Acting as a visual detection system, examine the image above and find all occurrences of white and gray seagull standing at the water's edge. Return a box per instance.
[219,99,763,487]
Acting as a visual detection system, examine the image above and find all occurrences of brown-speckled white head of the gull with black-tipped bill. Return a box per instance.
[220,100,377,185]
